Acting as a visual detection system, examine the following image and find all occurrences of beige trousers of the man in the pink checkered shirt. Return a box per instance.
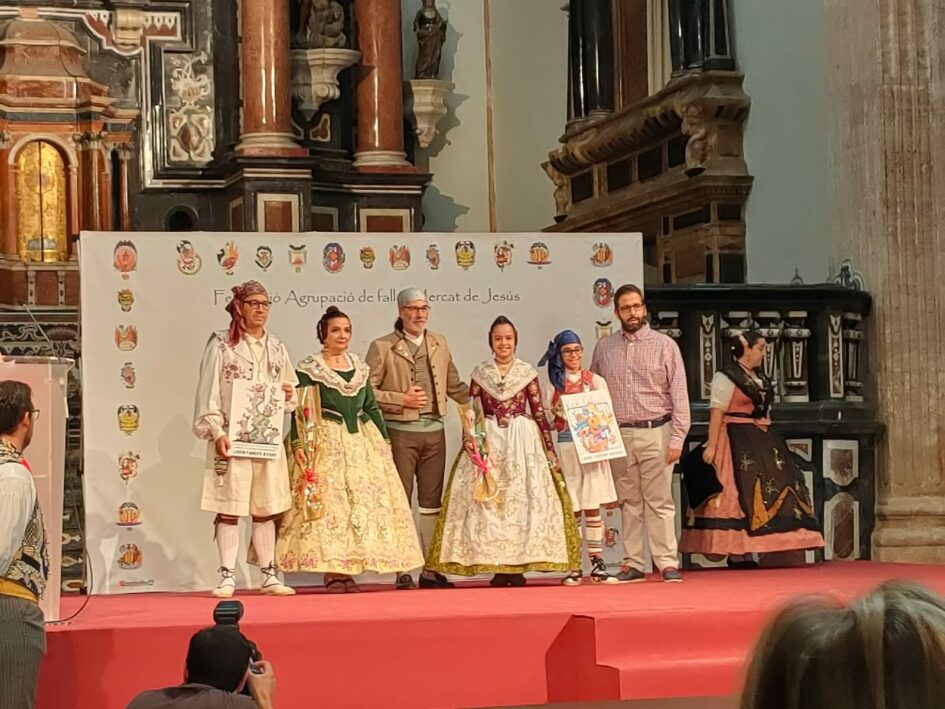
[611,423,679,571]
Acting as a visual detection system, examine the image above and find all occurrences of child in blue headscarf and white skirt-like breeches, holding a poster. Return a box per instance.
[538,330,619,586]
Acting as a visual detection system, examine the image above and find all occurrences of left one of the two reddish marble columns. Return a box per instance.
[236,0,307,157]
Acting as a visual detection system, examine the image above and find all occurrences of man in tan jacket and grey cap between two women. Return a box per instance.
[367,288,469,589]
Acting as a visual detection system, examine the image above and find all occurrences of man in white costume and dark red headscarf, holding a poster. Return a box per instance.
[194,281,298,598]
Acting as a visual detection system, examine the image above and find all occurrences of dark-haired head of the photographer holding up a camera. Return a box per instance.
[185,625,253,692]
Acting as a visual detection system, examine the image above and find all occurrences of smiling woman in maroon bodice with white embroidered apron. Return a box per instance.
[428,316,580,586]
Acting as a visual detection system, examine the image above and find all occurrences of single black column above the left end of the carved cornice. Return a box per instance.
[578,0,614,116]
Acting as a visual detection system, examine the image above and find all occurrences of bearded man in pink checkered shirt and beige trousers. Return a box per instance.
[591,284,690,583]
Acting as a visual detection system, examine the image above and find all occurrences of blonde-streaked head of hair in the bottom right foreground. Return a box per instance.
[741,581,945,709]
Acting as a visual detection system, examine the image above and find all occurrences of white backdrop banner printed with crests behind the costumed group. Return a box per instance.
[80,232,643,593]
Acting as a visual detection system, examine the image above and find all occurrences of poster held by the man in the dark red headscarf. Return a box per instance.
[228,379,285,460]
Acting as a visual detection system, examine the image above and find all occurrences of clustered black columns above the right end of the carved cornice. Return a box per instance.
[668,0,735,76]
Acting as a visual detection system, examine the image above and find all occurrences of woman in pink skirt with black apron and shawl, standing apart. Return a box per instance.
[679,332,824,568]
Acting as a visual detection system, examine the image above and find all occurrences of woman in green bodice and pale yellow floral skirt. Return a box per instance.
[276,307,423,593]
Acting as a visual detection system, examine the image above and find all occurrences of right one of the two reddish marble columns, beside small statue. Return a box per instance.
[354,0,413,171]
